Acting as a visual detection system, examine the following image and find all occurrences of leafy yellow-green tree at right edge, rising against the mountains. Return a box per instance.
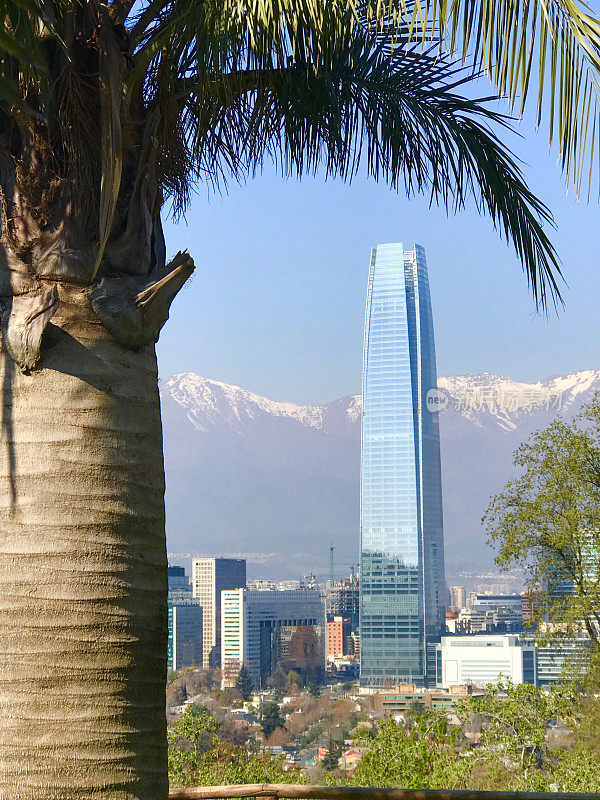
[484,397,600,646]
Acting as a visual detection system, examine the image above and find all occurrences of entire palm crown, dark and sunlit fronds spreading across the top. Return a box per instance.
[0,0,600,304]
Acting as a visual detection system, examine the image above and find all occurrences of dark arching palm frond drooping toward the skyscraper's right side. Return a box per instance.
[166,34,560,307]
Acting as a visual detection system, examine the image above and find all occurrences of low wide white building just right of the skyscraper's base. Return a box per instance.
[437,633,536,689]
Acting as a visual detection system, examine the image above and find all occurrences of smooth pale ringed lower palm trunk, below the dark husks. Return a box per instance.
[0,284,167,800]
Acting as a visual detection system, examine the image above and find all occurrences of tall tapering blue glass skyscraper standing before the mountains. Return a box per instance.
[360,244,447,686]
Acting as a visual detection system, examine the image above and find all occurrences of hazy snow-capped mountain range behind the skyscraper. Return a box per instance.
[161,370,600,578]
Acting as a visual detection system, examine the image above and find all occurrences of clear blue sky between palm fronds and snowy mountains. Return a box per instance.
[158,119,600,403]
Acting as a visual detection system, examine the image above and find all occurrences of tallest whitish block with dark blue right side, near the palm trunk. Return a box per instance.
[192,558,246,669]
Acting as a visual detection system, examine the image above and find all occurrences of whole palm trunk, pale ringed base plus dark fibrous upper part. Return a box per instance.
[0,37,194,788]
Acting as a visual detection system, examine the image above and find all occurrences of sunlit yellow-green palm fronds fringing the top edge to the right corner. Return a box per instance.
[132,0,600,197]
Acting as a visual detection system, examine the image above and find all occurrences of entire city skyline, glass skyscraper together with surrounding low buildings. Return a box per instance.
[169,244,588,696]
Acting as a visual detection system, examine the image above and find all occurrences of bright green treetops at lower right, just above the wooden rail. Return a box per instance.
[340,681,600,792]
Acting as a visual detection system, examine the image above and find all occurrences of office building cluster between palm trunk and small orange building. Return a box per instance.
[168,558,336,689]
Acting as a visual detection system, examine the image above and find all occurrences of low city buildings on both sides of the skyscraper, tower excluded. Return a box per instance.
[168,558,589,692]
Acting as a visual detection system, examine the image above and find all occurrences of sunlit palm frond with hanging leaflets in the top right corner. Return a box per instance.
[426,0,600,191]
